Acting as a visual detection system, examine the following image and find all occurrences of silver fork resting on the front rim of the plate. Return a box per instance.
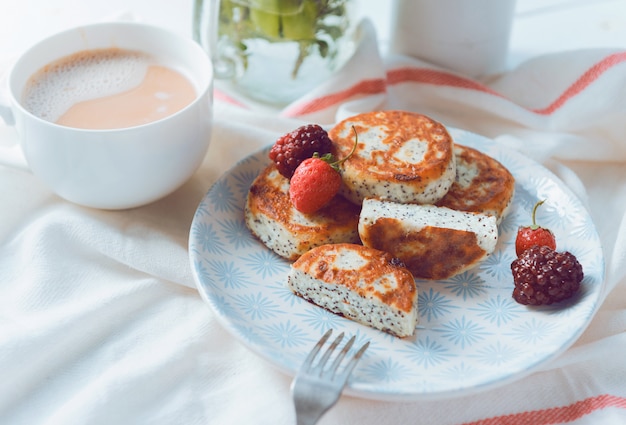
[291,329,370,425]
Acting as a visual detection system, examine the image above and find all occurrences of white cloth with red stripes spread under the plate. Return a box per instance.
[0,18,626,425]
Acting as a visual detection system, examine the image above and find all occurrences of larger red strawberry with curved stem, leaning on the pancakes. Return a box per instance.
[289,127,358,214]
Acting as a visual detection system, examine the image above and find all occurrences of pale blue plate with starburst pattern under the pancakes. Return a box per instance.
[189,130,604,400]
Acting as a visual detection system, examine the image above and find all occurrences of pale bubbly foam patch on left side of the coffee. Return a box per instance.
[22,48,152,122]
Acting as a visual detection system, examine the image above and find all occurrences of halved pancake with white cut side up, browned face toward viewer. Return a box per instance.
[359,199,498,280]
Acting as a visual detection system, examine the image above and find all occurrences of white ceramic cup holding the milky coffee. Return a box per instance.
[0,22,213,209]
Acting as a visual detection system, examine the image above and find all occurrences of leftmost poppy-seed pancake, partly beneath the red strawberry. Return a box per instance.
[244,163,360,261]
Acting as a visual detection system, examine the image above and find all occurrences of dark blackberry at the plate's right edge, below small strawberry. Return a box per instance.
[511,245,584,305]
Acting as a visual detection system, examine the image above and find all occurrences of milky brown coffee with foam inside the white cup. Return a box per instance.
[22,48,196,129]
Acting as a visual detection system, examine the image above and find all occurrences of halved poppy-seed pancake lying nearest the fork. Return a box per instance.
[287,244,417,337]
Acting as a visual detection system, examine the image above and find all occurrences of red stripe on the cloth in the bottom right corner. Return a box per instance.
[463,394,626,425]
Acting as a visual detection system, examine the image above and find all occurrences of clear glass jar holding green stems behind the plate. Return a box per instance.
[193,0,357,105]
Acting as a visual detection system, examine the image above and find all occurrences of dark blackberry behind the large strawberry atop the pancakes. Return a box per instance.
[269,124,333,179]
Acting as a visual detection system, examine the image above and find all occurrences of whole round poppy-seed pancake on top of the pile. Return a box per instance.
[329,111,456,204]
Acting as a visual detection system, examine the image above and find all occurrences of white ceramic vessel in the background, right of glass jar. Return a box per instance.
[390,0,516,78]
